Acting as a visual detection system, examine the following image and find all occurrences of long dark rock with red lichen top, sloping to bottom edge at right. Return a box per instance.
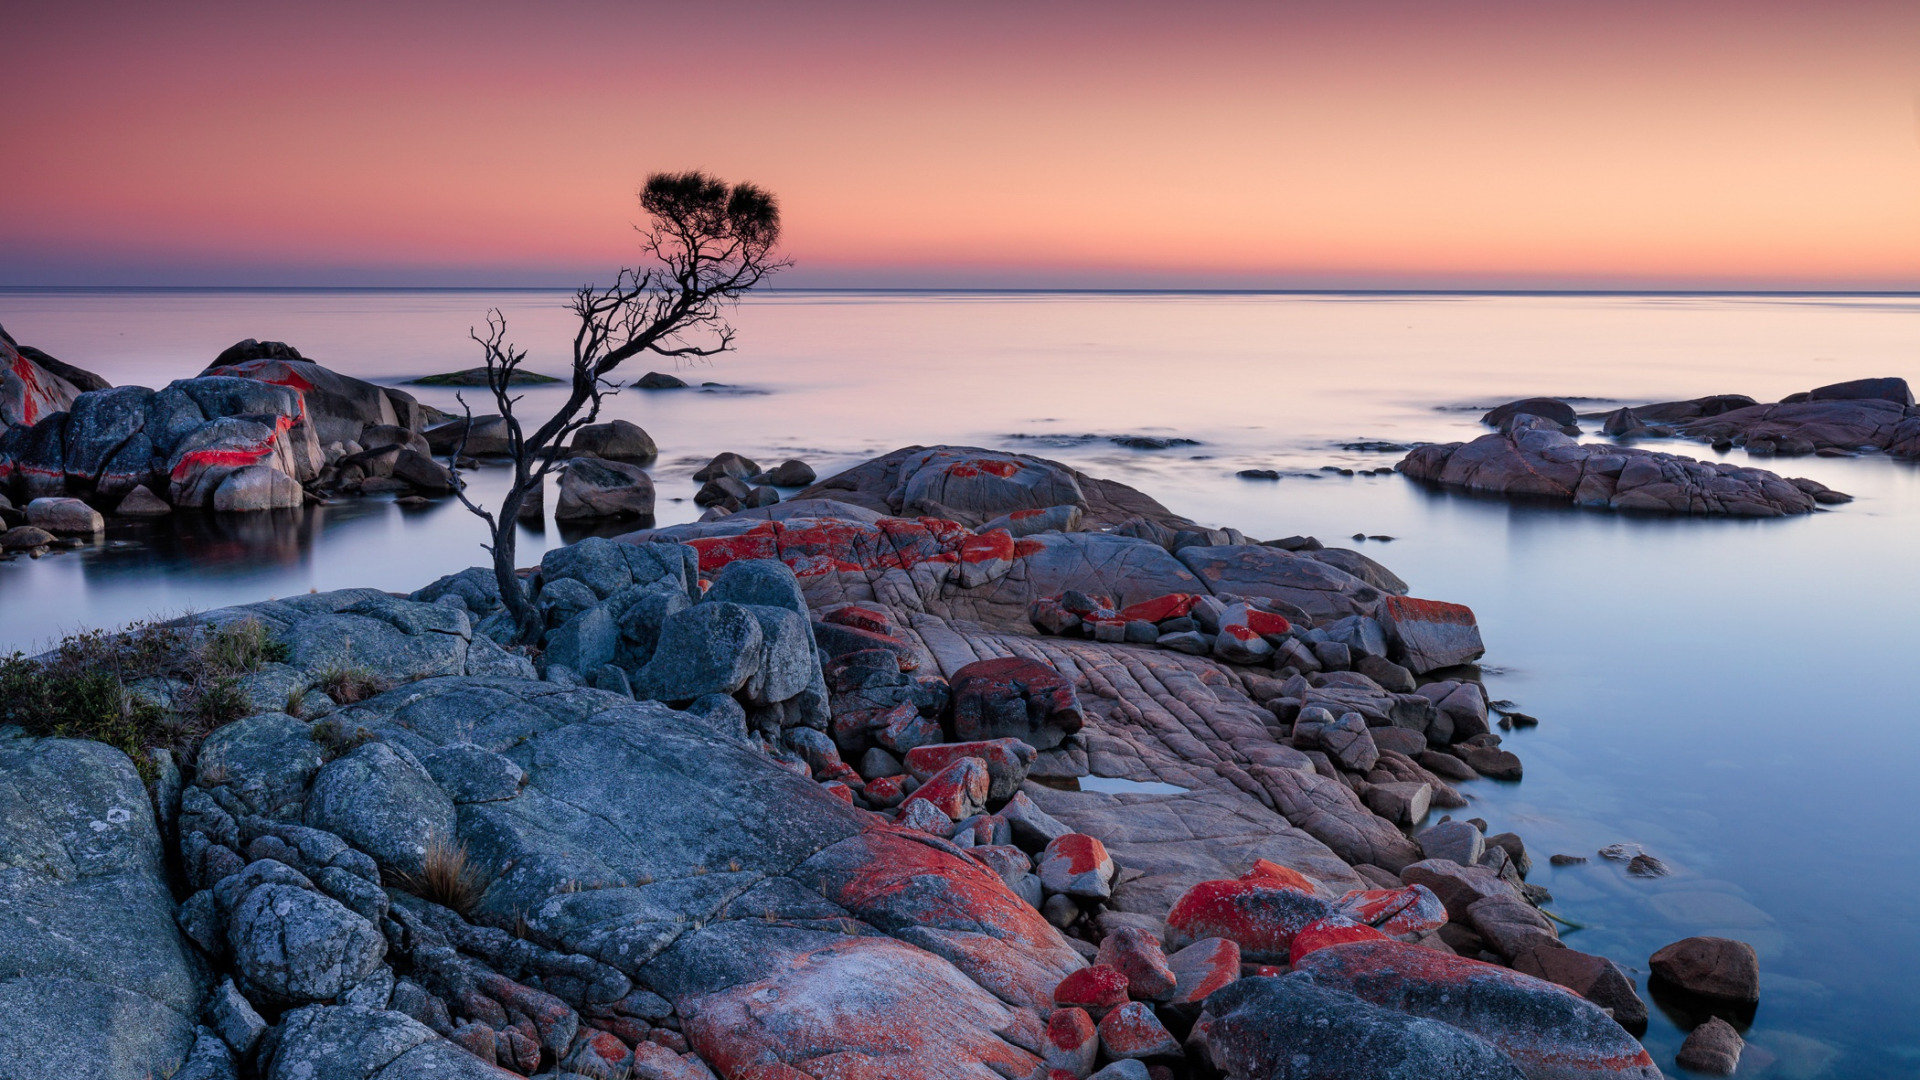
[1290,942,1661,1080]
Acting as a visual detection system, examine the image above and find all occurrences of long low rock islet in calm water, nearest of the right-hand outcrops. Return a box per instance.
[1396,413,1849,517]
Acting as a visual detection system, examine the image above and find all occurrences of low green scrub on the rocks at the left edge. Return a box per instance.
[0,619,288,778]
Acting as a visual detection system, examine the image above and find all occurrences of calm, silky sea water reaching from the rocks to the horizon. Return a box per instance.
[0,290,1920,1080]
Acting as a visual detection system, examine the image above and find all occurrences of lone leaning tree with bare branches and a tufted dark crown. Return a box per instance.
[449,171,791,644]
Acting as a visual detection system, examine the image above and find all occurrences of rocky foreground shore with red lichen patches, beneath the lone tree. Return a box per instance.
[0,440,1757,1080]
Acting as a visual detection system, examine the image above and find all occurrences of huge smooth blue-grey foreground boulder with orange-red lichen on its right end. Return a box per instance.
[276,676,1083,1078]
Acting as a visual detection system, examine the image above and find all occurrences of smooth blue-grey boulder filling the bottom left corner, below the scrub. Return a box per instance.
[0,738,209,1080]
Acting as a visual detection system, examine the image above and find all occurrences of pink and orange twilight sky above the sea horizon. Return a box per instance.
[0,0,1920,290]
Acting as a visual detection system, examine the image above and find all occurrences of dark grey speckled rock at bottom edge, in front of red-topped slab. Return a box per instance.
[1190,968,1524,1080]
